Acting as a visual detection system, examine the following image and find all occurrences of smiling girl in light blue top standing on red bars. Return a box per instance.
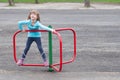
[17,10,56,66]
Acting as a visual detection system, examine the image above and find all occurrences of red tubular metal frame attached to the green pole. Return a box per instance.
[13,28,76,72]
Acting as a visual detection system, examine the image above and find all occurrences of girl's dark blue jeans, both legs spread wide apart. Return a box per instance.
[22,37,46,61]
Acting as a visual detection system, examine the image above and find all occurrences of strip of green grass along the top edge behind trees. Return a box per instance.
[0,0,120,3]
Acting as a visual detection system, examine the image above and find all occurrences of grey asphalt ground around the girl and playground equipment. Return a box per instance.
[0,9,120,80]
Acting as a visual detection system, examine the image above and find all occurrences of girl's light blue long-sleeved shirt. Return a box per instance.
[18,20,53,37]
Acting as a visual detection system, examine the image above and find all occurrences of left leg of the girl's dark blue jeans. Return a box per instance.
[22,37,34,59]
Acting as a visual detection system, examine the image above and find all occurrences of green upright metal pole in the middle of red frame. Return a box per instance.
[48,25,53,72]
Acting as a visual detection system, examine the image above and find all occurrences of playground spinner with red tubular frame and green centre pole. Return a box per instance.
[13,26,76,72]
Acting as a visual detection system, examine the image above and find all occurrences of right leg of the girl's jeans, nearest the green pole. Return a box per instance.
[35,38,46,61]
